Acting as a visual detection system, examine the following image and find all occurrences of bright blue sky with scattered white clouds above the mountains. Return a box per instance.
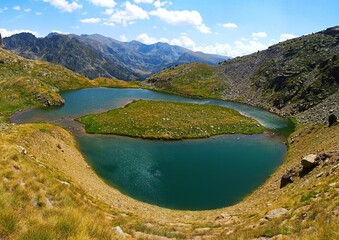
[0,0,339,57]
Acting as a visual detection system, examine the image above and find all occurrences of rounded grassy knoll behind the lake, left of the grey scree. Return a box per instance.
[143,63,225,98]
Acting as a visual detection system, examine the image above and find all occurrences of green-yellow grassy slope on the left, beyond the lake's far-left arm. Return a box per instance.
[0,48,138,122]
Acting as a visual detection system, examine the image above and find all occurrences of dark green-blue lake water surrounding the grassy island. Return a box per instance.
[12,88,291,210]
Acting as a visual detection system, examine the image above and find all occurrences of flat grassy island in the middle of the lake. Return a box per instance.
[77,100,265,140]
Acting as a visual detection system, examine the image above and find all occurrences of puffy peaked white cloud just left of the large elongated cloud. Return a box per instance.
[105,2,149,26]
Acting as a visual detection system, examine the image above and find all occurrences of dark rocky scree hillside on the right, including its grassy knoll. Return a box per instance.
[144,27,339,123]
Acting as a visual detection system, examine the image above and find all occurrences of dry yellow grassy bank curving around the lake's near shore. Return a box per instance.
[0,124,339,239]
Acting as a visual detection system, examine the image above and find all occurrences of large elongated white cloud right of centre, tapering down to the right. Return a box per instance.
[150,8,210,33]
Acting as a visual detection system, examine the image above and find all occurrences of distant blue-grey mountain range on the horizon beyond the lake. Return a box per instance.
[3,33,227,81]
